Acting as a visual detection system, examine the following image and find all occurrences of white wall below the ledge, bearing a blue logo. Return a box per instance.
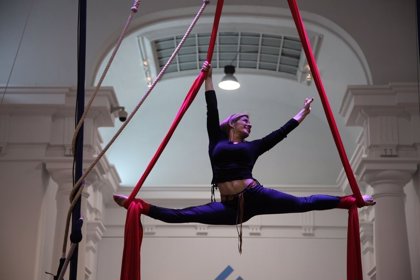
[98,236,346,280]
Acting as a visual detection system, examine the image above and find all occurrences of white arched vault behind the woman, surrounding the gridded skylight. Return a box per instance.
[97,4,370,186]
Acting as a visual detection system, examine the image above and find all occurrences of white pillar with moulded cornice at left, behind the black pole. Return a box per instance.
[0,87,119,280]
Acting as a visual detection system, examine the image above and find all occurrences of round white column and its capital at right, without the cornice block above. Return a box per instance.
[364,170,412,280]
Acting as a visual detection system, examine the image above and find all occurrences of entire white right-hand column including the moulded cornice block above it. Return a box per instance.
[341,84,420,280]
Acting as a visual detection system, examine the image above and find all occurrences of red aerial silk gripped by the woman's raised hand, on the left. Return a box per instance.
[121,0,224,280]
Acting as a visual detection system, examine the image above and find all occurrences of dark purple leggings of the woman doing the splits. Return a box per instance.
[147,185,340,225]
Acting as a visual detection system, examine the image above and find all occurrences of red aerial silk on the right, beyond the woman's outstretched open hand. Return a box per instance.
[288,0,364,280]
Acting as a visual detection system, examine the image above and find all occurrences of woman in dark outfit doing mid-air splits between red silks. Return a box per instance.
[114,62,375,252]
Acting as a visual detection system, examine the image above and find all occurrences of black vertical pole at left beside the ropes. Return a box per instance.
[69,0,87,280]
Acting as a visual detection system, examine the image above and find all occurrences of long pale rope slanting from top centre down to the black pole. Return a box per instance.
[62,0,209,264]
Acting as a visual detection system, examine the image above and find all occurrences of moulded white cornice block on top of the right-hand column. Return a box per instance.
[340,84,420,159]
